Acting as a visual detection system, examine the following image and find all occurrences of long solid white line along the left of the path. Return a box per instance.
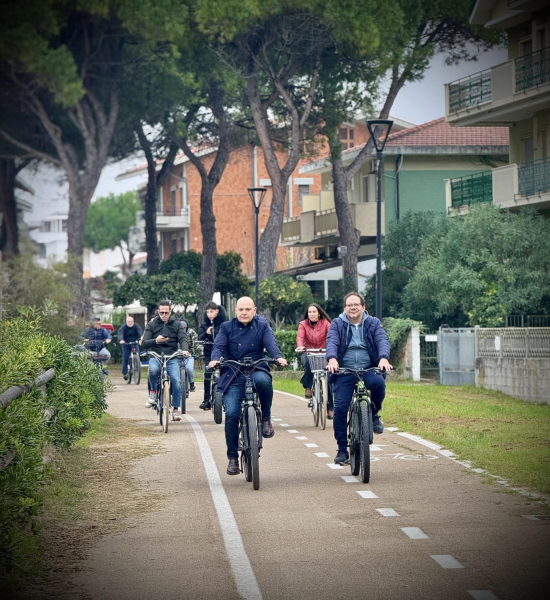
[185,414,262,600]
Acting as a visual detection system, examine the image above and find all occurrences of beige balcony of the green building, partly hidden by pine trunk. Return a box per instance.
[281,192,385,246]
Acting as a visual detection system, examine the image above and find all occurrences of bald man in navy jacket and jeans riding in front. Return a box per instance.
[208,296,287,475]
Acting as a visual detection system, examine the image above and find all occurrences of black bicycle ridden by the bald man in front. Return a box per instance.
[220,358,279,490]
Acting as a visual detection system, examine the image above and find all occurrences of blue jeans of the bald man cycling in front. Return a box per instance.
[223,371,273,458]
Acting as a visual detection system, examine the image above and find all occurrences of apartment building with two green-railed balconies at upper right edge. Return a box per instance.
[445,0,550,215]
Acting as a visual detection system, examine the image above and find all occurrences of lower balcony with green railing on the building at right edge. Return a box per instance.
[446,158,550,216]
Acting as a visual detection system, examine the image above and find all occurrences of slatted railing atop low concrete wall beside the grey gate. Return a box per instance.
[476,327,550,358]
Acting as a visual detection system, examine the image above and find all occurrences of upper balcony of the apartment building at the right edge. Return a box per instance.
[445,47,550,126]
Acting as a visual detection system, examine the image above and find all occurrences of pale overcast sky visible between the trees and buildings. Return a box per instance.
[22,49,507,221]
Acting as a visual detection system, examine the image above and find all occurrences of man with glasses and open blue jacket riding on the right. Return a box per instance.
[327,292,393,464]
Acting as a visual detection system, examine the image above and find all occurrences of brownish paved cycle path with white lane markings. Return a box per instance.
[74,379,550,600]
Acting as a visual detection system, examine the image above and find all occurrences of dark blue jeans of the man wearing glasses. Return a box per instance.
[332,373,386,451]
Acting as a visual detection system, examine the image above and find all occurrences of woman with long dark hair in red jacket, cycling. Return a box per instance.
[296,302,334,419]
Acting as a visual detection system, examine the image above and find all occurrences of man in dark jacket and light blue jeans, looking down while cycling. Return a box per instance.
[143,300,189,421]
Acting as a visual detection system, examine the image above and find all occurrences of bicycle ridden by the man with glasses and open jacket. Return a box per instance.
[337,367,386,483]
